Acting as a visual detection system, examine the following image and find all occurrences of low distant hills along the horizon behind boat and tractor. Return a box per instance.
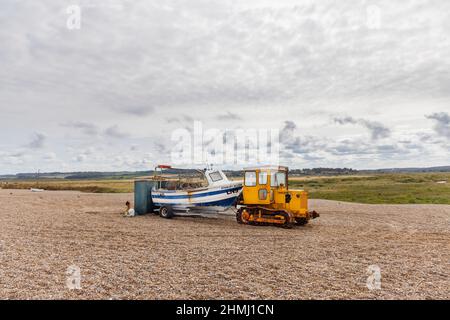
[0,166,450,180]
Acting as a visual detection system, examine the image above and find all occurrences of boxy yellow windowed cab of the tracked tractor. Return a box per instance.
[242,166,288,205]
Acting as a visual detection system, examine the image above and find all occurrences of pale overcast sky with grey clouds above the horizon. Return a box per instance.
[0,0,450,174]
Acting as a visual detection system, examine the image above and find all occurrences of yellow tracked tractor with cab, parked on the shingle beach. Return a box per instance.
[236,166,319,228]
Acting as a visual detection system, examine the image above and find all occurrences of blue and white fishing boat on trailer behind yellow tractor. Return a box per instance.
[151,165,242,216]
